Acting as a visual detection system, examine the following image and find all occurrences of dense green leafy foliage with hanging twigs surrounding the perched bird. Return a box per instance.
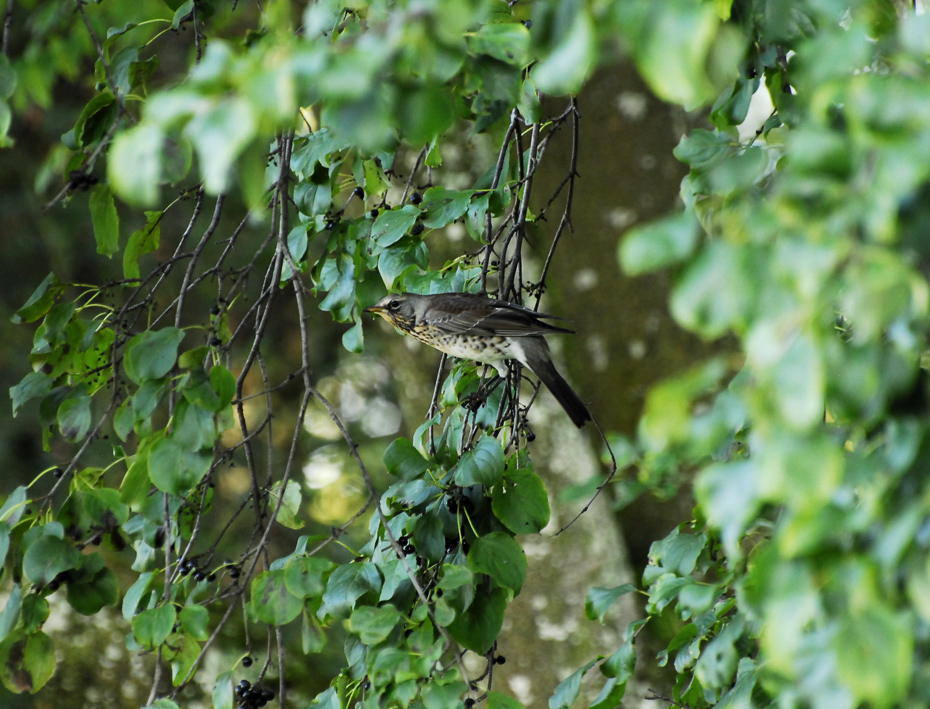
[0,0,930,709]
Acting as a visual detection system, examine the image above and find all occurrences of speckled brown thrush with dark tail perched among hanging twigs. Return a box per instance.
[363,293,591,428]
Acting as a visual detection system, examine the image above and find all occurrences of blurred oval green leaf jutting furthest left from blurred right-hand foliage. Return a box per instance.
[619,212,700,276]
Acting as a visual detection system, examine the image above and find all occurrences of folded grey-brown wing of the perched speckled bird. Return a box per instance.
[420,296,571,337]
